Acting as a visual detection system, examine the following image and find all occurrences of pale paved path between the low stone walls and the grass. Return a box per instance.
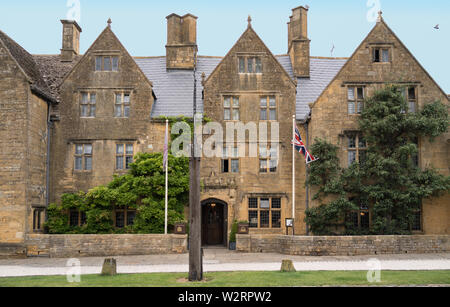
[0,248,450,278]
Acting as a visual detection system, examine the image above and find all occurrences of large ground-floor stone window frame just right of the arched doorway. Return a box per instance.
[247,199,283,229]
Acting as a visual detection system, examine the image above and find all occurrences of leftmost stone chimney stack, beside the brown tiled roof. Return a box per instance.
[61,20,82,62]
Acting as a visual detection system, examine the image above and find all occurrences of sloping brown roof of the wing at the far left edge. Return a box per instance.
[0,31,57,103]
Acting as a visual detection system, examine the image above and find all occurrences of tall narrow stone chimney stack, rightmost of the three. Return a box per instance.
[288,6,311,78]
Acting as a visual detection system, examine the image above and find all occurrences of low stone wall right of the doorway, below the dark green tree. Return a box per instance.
[236,235,450,256]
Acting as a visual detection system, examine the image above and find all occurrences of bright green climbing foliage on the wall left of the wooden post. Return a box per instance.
[46,153,189,234]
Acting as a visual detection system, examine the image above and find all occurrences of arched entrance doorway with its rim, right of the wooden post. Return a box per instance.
[202,198,228,246]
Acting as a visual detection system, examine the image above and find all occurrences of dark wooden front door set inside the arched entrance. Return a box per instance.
[202,203,224,245]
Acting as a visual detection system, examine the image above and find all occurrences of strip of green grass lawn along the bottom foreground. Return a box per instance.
[0,271,450,287]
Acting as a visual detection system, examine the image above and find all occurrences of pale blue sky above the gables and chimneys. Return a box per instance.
[0,0,450,93]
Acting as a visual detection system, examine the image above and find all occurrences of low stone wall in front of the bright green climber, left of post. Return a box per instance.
[25,234,187,258]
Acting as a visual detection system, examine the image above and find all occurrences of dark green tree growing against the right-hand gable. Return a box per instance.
[305,86,450,235]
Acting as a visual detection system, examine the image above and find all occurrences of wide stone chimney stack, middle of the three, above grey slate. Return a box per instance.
[166,14,197,70]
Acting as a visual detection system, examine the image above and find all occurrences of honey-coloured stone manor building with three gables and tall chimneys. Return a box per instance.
[0,7,450,251]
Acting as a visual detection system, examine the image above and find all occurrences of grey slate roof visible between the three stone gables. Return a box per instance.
[135,55,347,120]
